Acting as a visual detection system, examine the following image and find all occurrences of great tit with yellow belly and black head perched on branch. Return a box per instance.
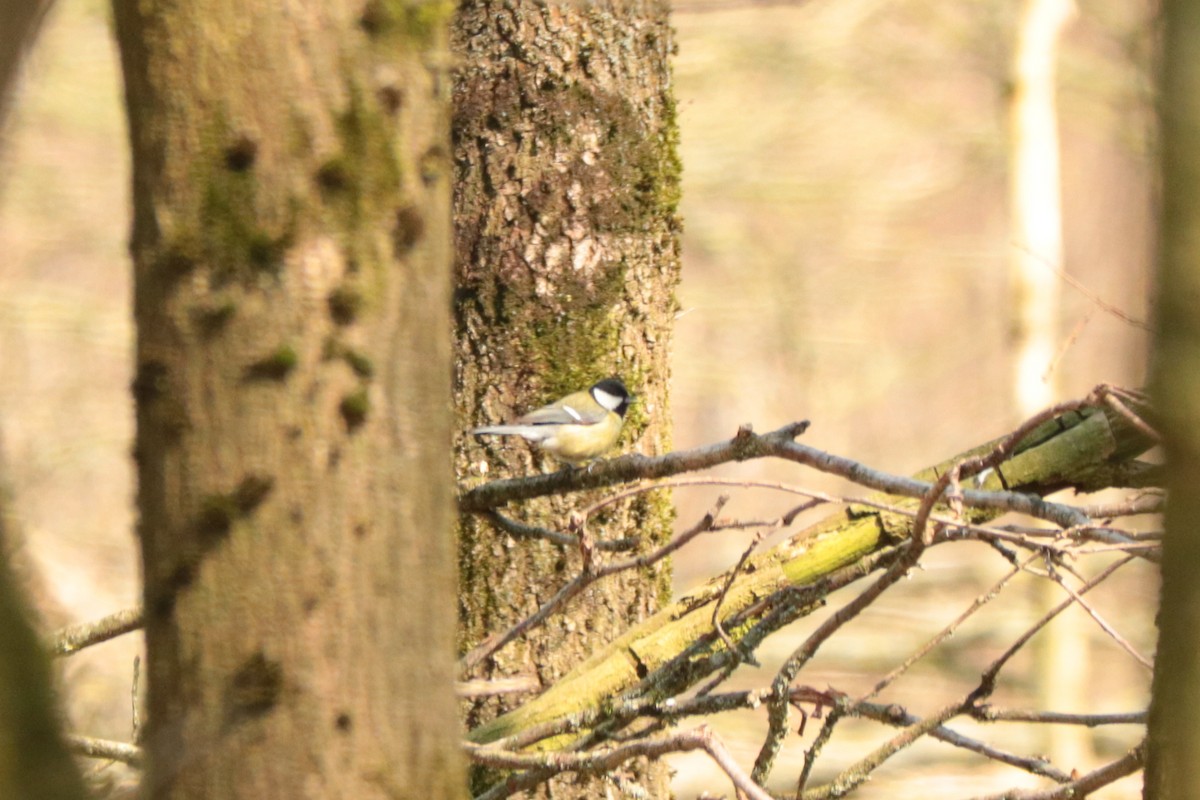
[470,378,634,467]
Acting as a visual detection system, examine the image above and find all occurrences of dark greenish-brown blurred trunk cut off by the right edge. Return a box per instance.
[1145,0,1200,800]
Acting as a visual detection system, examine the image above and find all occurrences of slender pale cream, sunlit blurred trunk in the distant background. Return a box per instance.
[1009,0,1091,770]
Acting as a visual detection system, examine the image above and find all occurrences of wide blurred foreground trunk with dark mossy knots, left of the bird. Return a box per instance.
[114,0,464,800]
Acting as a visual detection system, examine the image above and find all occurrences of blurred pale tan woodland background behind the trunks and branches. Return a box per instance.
[0,0,1157,798]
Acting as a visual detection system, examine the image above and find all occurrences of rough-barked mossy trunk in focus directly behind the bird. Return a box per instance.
[454,0,679,796]
